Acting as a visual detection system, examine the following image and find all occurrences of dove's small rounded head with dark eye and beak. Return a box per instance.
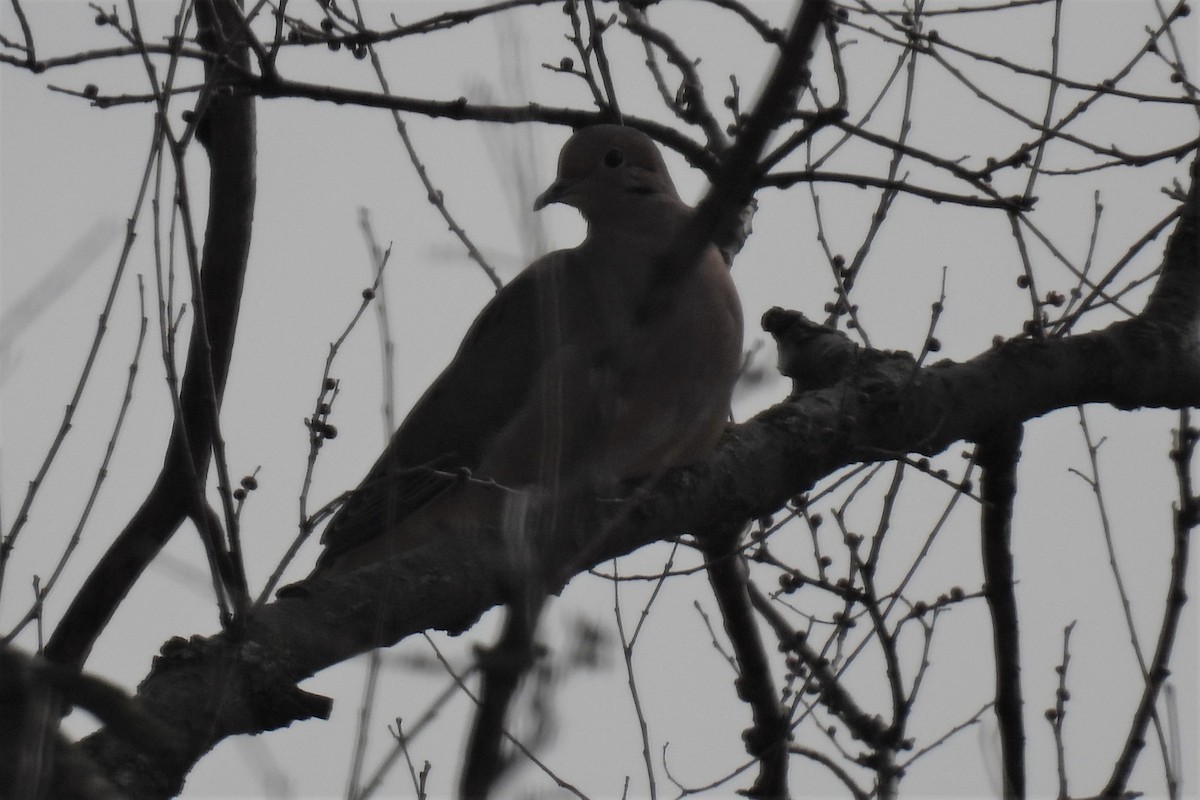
[533,125,679,223]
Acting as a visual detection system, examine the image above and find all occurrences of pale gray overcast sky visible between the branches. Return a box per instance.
[0,0,1198,798]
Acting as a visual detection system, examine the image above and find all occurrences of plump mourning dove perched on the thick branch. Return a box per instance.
[317,125,742,572]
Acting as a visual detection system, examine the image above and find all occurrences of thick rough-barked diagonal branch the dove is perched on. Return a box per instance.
[75,214,1200,796]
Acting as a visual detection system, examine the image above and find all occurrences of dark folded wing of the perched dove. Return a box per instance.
[318,251,572,565]
